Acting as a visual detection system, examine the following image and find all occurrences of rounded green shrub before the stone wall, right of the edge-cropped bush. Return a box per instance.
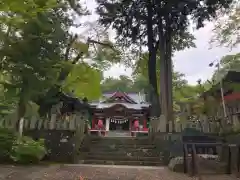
[11,136,47,164]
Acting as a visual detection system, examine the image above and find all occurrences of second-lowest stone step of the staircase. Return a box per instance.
[84,154,160,162]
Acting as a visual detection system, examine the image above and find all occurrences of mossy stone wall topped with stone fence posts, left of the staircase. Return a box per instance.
[0,112,88,163]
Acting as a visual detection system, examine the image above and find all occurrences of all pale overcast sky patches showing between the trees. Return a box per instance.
[74,0,240,84]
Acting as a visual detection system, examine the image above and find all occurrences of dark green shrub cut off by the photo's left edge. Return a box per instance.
[0,128,17,161]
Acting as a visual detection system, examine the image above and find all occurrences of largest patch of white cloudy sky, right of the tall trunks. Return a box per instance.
[173,23,240,84]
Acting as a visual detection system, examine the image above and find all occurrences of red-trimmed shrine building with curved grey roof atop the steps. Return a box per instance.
[90,91,150,136]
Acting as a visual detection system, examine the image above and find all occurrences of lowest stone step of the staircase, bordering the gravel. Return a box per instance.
[79,160,163,166]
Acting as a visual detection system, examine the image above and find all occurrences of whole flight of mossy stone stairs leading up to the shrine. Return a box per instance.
[79,137,163,166]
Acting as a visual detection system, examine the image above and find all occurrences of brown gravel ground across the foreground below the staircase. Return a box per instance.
[0,165,237,180]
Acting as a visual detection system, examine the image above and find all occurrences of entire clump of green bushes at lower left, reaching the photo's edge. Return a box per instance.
[0,128,47,164]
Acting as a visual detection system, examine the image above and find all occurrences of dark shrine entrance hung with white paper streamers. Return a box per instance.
[109,118,130,131]
